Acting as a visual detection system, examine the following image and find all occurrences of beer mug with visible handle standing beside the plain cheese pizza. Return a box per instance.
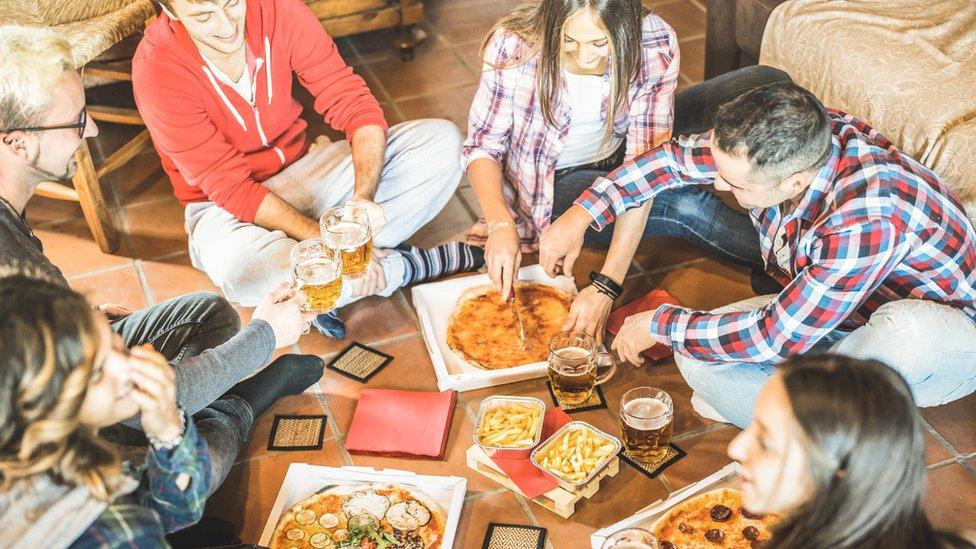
[549,332,617,405]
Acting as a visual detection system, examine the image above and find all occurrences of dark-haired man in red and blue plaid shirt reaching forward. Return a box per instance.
[540,82,976,428]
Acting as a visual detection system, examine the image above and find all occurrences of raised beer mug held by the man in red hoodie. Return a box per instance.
[319,205,373,278]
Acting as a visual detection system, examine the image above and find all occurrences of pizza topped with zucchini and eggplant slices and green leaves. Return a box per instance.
[270,483,447,549]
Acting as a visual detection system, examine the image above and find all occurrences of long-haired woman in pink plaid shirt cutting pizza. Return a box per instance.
[462,0,785,338]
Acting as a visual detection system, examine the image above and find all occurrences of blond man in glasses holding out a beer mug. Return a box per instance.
[0,25,324,516]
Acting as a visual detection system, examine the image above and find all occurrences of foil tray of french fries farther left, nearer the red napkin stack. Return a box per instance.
[474,396,546,459]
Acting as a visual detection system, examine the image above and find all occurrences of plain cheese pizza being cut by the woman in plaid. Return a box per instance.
[447,282,573,370]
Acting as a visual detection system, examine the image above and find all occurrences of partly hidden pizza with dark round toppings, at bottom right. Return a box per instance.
[651,488,779,549]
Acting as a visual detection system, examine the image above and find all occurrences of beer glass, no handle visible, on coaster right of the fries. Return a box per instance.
[620,387,674,462]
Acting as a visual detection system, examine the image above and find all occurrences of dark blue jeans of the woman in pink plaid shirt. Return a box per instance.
[552,66,789,269]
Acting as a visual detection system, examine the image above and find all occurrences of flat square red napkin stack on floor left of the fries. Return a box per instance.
[346,389,457,459]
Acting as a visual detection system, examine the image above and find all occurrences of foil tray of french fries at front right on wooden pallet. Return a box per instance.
[530,421,621,491]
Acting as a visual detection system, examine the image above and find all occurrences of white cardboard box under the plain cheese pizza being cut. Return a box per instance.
[412,265,576,391]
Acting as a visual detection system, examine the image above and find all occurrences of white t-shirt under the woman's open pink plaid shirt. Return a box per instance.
[556,70,623,169]
